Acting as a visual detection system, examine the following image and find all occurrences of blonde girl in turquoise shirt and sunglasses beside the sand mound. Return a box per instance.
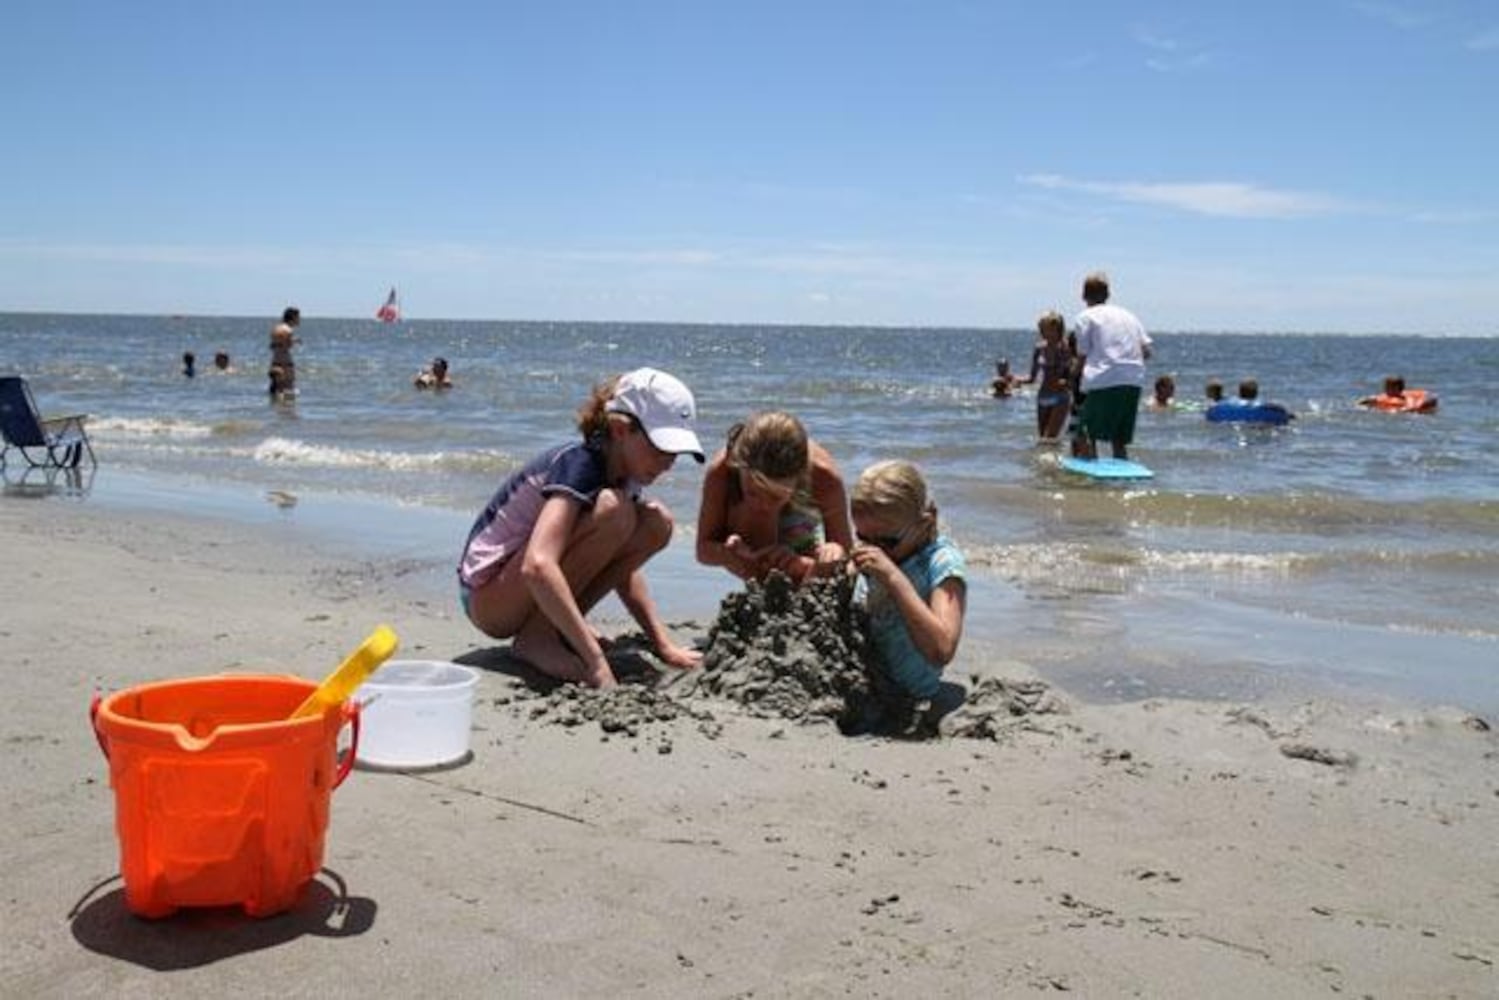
[851,462,967,710]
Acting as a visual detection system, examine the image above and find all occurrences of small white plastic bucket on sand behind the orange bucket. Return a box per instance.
[355,660,478,771]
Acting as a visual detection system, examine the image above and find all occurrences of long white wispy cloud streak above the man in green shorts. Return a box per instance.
[1018,174,1351,219]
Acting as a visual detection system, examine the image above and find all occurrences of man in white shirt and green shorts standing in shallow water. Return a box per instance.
[1072,271,1150,459]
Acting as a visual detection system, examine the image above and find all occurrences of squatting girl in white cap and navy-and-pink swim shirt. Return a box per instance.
[459,367,703,687]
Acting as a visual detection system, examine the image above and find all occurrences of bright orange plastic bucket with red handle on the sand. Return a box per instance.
[91,675,360,918]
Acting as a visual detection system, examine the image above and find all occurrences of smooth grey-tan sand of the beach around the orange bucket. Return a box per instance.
[0,499,1499,997]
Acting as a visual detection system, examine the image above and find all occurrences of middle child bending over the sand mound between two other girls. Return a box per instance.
[697,412,853,582]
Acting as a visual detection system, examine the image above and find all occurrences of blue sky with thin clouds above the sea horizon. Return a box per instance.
[0,0,1499,334]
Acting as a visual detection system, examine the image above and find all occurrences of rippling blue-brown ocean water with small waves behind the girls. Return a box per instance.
[0,313,1499,711]
